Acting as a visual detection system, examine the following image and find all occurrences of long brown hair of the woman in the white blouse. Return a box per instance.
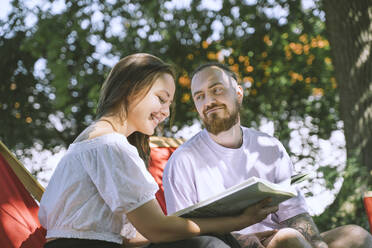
[97,53,175,166]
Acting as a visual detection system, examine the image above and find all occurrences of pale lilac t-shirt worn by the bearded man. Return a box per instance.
[163,127,307,234]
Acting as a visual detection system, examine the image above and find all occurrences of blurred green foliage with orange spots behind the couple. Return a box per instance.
[0,0,370,231]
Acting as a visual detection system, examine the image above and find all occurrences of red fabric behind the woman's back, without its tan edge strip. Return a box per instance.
[0,154,46,248]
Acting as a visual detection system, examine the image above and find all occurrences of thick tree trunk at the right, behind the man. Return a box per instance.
[319,0,372,227]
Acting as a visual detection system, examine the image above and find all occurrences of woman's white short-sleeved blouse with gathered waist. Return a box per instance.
[39,133,158,244]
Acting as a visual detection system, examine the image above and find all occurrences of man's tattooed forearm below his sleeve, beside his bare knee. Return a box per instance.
[280,213,328,248]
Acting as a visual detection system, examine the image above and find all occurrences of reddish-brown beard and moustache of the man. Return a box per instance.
[202,99,240,135]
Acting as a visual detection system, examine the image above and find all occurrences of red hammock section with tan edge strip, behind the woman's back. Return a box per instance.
[0,141,45,248]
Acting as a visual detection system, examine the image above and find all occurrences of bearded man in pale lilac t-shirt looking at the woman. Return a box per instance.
[163,63,372,248]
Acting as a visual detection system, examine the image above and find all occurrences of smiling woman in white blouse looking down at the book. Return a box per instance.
[39,54,277,248]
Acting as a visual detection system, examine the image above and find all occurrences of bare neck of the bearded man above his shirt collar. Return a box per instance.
[208,121,243,148]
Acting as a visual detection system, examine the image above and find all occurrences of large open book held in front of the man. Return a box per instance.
[173,174,307,218]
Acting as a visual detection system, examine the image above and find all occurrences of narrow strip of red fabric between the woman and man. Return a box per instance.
[149,147,177,214]
